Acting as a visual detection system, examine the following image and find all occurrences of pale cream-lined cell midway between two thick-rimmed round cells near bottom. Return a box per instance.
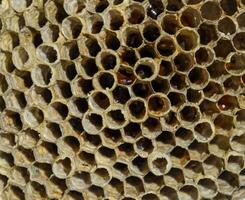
[91,167,112,186]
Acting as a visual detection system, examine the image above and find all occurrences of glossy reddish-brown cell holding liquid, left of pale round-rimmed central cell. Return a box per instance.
[117,65,135,85]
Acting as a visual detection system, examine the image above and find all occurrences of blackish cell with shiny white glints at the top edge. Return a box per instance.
[147,0,164,19]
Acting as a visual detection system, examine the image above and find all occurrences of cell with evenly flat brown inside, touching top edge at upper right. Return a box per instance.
[201,1,222,20]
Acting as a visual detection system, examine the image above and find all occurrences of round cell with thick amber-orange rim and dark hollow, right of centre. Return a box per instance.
[148,93,170,117]
